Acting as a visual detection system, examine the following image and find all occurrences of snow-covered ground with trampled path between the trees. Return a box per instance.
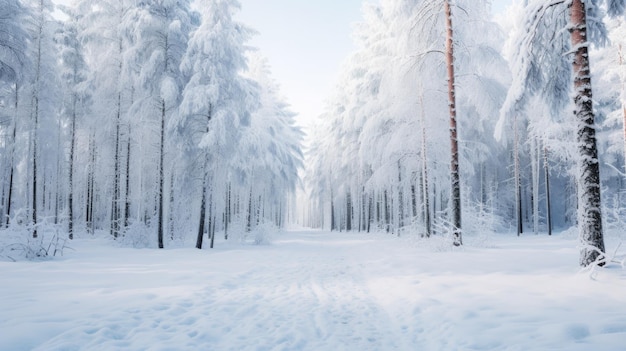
[0,231,626,351]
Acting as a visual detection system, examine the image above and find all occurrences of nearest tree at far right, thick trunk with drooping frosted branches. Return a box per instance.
[494,0,626,266]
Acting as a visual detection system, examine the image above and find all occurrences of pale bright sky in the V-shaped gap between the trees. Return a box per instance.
[237,0,513,135]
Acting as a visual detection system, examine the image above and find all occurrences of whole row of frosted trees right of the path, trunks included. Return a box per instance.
[302,0,626,266]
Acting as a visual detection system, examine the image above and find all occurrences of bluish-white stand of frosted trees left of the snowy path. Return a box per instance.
[0,0,302,252]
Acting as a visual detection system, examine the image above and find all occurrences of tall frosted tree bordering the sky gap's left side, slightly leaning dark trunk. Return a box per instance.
[174,0,255,249]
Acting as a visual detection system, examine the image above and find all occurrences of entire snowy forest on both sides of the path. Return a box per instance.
[0,0,626,266]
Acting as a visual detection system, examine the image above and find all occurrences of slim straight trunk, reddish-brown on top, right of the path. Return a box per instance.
[444,0,463,246]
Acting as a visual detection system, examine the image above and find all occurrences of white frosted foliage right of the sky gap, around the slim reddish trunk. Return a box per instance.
[307,0,509,235]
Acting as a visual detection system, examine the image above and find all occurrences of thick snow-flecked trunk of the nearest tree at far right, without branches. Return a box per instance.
[570,0,605,267]
